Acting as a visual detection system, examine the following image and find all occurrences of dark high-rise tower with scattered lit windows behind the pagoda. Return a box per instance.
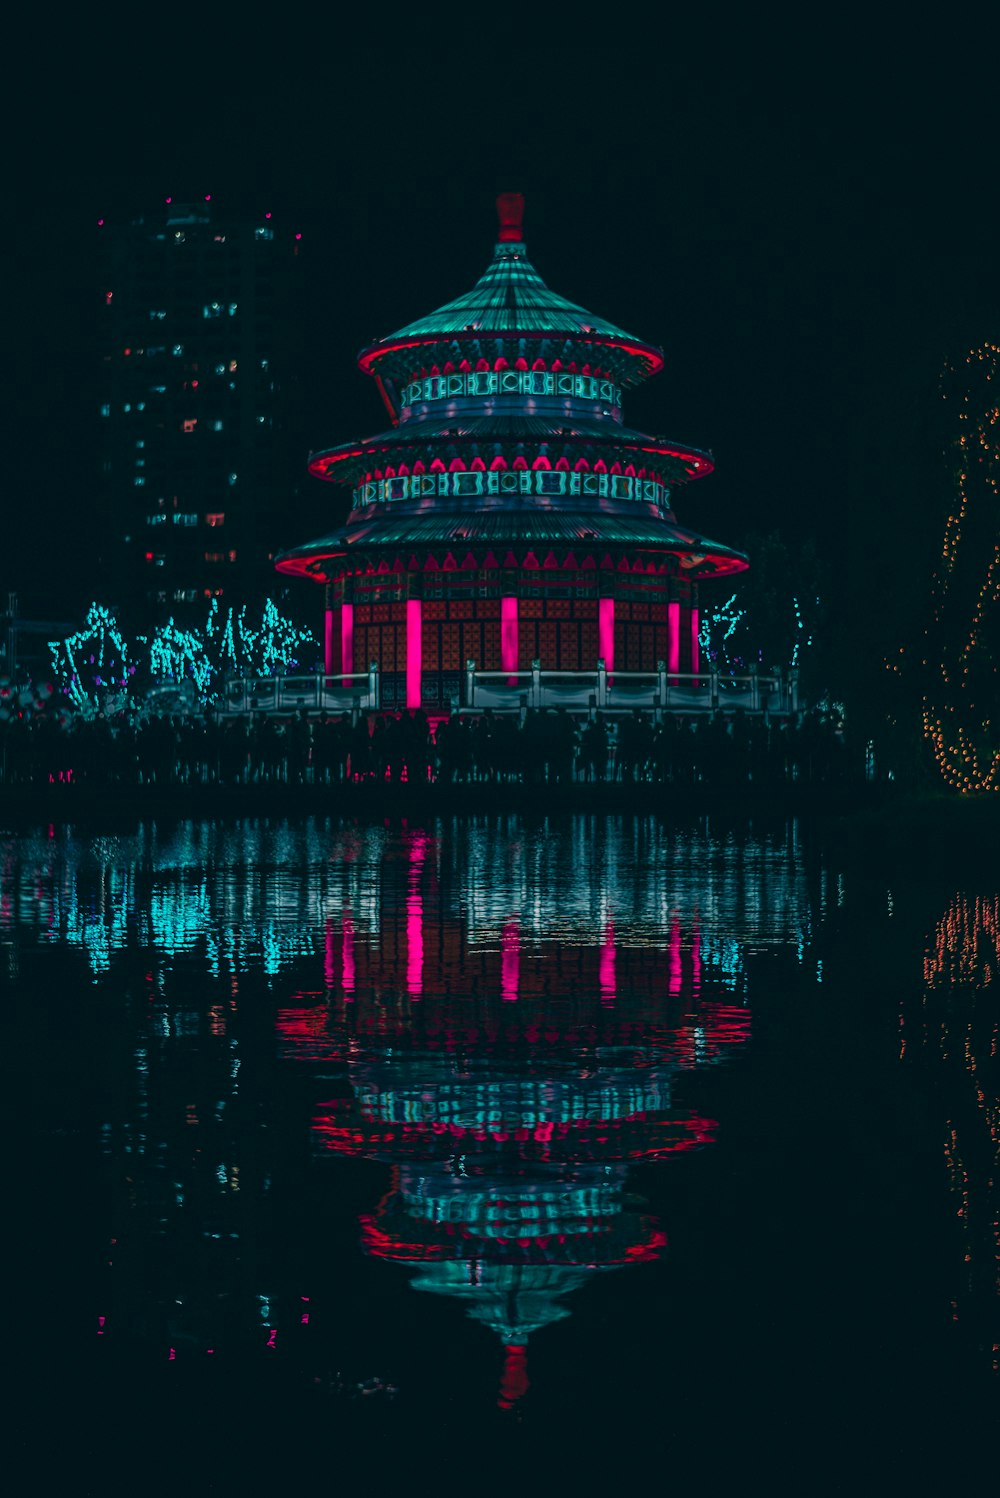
[97,198,301,619]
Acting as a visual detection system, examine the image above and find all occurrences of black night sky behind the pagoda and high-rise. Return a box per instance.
[0,6,1000,608]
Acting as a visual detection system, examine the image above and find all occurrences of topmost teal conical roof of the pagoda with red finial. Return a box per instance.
[358,193,663,400]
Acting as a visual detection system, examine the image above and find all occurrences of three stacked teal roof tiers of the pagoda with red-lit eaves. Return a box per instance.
[277,193,746,581]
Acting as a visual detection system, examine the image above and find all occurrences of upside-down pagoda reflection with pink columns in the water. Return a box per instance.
[278,833,750,1408]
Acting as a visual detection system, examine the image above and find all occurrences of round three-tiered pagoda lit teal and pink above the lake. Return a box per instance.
[277,193,747,709]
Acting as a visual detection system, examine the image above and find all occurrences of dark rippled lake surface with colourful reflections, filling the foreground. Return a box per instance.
[0,816,1000,1494]
